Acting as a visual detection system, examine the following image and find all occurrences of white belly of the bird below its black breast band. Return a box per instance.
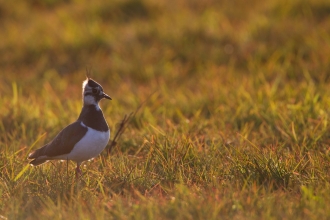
[65,128,110,162]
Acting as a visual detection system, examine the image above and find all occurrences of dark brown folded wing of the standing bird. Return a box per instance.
[29,121,88,159]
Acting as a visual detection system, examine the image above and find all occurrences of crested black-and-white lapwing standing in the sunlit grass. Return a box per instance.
[28,77,112,178]
